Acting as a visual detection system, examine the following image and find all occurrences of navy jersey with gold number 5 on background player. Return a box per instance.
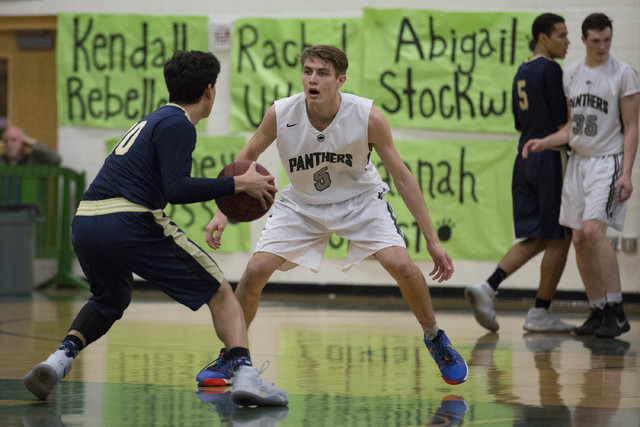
[512,56,568,152]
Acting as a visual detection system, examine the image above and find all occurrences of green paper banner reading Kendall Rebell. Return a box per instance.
[56,13,208,129]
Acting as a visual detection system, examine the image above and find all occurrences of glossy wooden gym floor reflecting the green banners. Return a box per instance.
[0,291,640,427]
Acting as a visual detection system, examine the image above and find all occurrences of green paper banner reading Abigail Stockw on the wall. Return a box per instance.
[362,9,538,133]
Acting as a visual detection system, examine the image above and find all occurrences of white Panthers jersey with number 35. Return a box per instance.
[563,56,640,157]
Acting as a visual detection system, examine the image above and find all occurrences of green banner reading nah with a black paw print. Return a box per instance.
[325,141,516,261]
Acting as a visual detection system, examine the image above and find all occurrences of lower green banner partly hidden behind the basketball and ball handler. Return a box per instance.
[106,136,253,252]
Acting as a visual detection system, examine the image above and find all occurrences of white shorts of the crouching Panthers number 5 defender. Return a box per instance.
[255,184,406,272]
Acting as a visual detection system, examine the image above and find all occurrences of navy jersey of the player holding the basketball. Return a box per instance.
[84,104,235,210]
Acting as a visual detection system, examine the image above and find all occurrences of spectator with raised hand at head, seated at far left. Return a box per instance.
[0,126,61,166]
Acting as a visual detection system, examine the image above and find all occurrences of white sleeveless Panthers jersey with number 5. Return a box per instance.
[275,93,382,204]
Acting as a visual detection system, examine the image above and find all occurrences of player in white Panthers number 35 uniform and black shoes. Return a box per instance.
[522,13,640,338]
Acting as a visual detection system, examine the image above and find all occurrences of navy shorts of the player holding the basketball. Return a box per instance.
[71,201,224,320]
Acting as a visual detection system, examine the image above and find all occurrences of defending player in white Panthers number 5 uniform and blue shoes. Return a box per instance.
[201,45,467,384]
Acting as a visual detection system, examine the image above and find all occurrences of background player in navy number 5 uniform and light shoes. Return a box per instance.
[465,13,573,332]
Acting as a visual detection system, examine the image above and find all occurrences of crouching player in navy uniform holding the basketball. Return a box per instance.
[24,51,288,405]
